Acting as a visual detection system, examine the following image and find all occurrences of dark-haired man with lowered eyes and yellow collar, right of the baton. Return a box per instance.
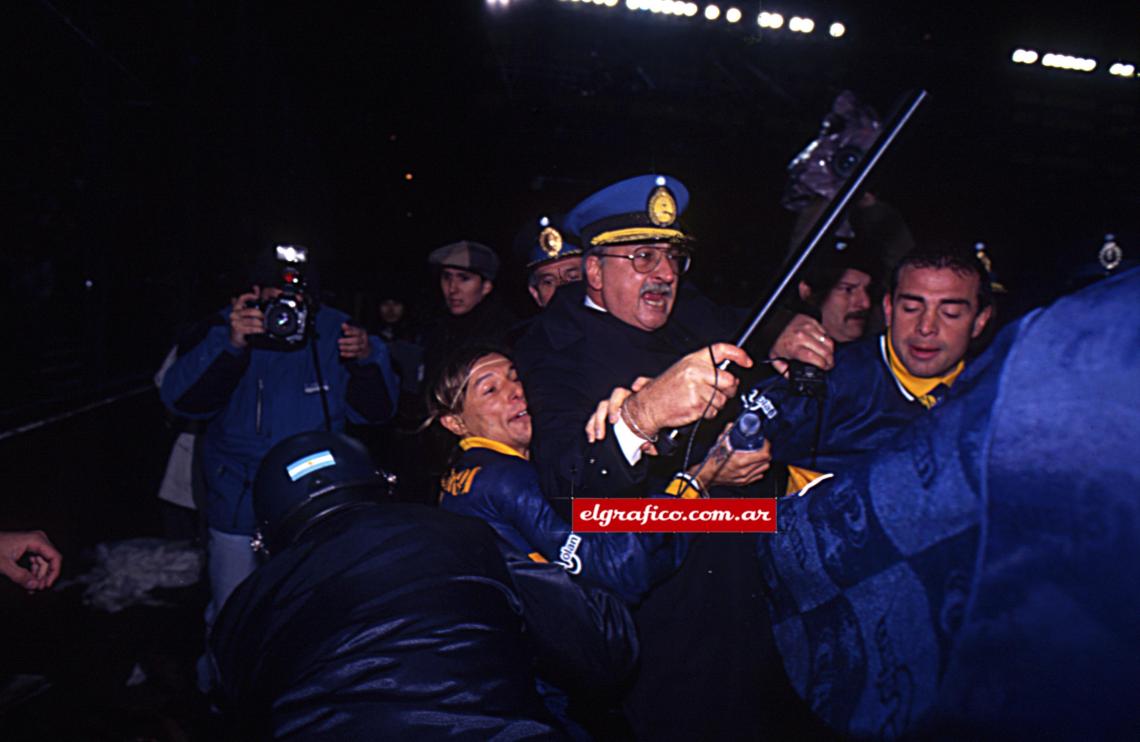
[746,240,993,491]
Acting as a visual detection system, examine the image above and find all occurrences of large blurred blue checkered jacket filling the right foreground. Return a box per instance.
[759,269,1140,740]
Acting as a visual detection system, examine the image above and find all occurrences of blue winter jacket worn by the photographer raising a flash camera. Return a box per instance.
[161,307,399,533]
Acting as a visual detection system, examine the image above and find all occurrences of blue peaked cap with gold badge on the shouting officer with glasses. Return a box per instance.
[567,176,692,252]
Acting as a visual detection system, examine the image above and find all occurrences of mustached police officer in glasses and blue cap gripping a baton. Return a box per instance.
[514,174,831,740]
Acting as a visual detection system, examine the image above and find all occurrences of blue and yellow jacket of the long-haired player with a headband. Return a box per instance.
[440,437,686,603]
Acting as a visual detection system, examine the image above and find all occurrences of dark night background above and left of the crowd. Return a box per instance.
[0,0,1140,740]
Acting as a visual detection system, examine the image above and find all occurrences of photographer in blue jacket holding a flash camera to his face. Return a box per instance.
[162,245,398,683]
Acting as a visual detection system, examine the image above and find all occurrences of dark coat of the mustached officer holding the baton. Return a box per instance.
[514,283,806,740]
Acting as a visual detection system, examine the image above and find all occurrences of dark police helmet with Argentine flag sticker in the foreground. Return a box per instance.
[253,432,394,554]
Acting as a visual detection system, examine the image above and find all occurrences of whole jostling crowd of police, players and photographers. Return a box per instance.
[13,165,1140,740]
